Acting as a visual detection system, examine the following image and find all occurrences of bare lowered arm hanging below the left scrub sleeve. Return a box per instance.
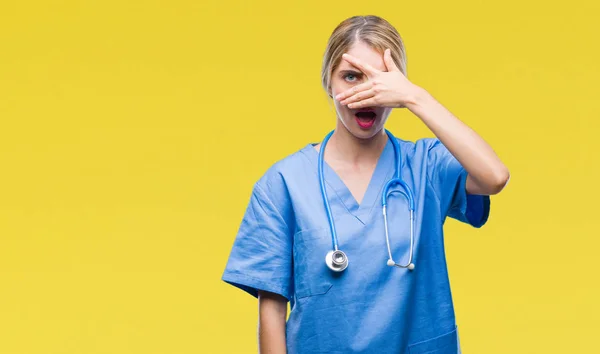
[258,291,287,354]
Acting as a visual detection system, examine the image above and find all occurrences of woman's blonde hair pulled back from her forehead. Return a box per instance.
[321,15,406,97]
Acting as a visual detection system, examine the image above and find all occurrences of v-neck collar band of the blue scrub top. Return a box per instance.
[302,139,396,224]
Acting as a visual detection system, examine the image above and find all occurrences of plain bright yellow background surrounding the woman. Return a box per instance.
[0,0,600,354]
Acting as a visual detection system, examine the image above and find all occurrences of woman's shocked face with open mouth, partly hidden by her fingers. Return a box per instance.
[331,41,392,139]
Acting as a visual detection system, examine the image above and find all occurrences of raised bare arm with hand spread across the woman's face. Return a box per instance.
[335,50,510,195]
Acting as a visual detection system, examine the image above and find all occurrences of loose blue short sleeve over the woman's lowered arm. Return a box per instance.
[222,184,293,300]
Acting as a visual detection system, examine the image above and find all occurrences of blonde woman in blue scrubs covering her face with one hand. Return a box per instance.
[223,16,509,354]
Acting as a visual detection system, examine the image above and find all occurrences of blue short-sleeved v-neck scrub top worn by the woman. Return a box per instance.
[222,134,490,354]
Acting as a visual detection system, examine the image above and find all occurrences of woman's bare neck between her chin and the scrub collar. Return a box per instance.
[329,124,388,164]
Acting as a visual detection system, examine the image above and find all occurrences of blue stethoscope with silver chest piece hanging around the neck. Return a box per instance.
[318,130,415,272]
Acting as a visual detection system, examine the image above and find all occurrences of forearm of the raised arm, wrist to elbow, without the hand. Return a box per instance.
[406,88,509,195]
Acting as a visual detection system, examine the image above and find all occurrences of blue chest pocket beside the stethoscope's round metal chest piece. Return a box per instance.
[293,228,333,299]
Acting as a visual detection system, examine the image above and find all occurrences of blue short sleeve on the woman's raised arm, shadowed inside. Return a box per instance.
[428,139,490,228]
